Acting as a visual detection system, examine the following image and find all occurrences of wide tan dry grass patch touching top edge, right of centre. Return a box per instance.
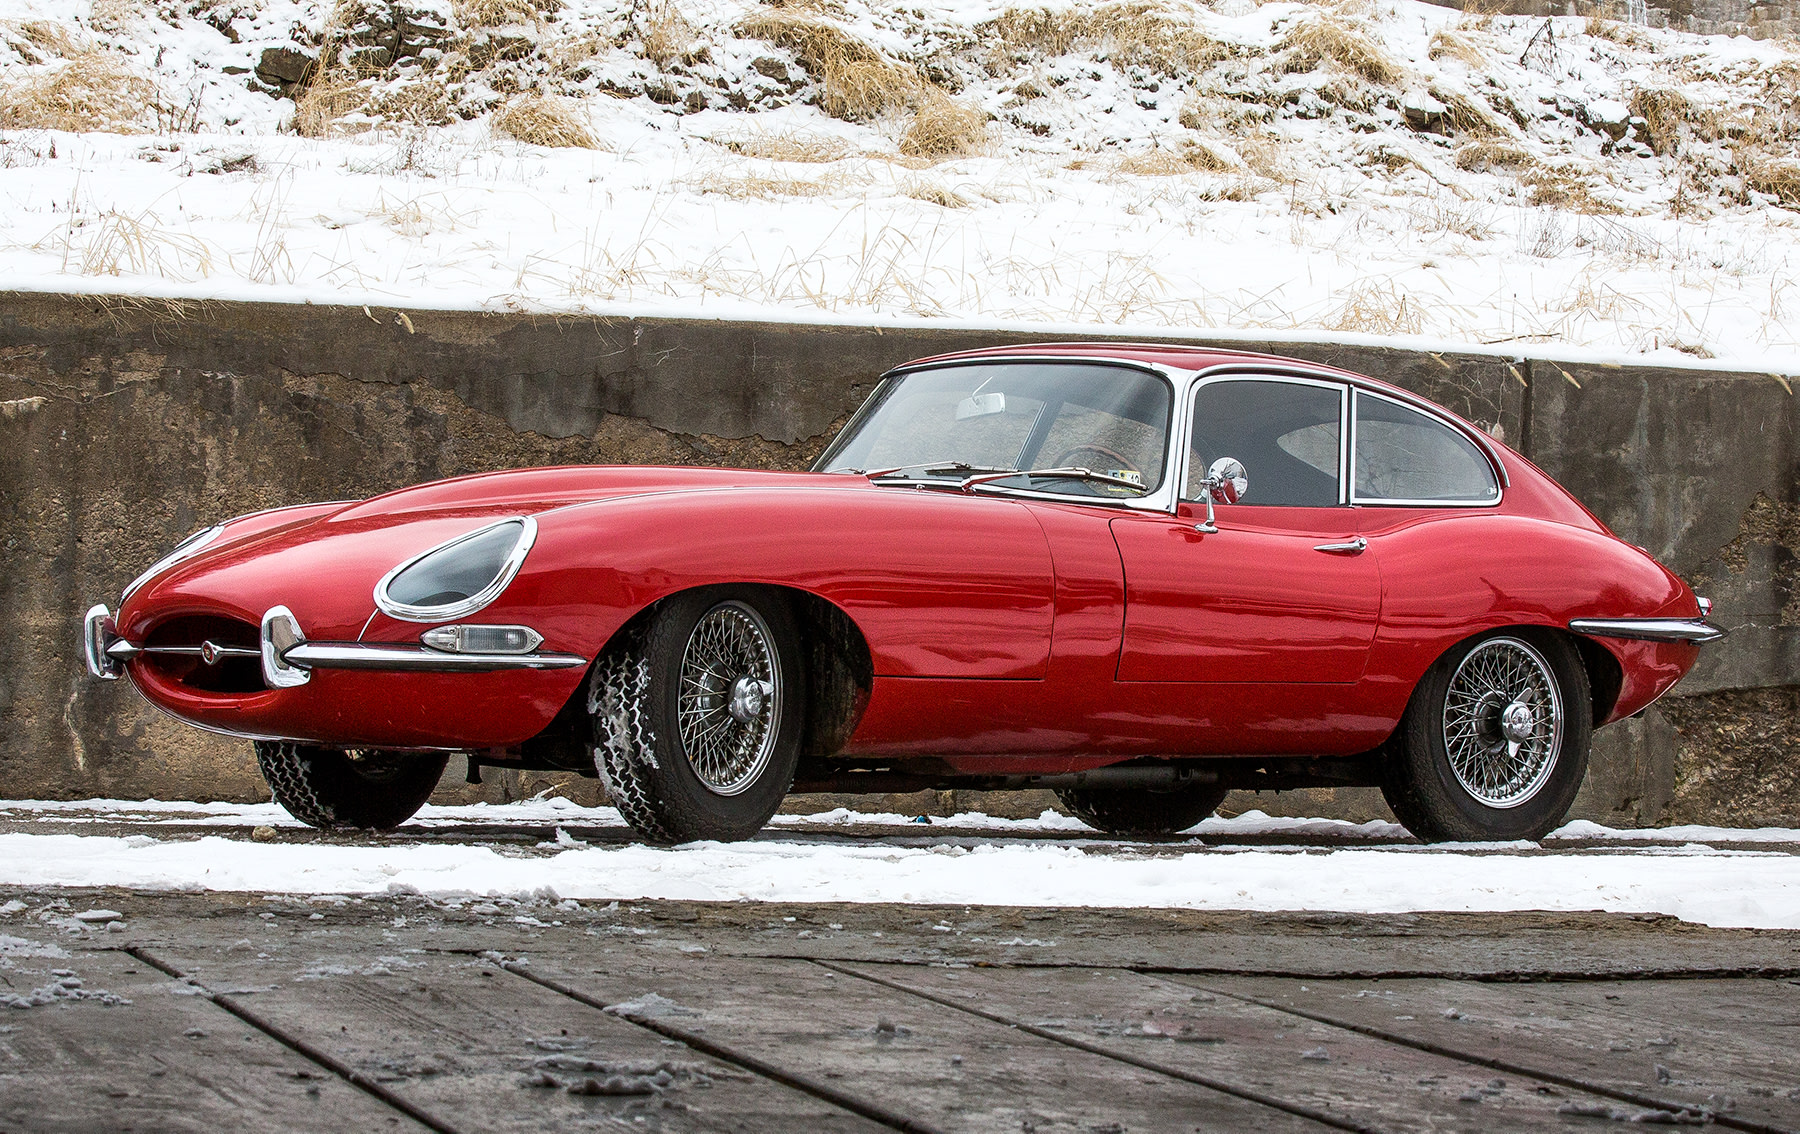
[976,0,1231,76]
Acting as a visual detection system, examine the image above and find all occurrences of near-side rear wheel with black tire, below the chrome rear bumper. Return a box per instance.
[1381,630,1593,842]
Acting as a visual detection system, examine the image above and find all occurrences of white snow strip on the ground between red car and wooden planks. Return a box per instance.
[0,799,1800,929]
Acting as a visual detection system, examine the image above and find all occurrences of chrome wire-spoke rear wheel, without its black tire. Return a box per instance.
[1444,637,1562,808]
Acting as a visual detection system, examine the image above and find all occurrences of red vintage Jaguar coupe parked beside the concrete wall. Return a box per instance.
[83,344,1721,842]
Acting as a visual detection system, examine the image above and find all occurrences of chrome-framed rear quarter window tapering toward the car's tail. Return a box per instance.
[1355,391,1499,504]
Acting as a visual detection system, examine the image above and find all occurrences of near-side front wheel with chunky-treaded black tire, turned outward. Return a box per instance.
[587,587,806,842]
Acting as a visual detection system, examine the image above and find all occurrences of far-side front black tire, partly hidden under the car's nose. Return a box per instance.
[256,740,450,832]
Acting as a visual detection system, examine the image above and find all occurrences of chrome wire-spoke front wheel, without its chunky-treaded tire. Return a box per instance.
[679,601,783,796]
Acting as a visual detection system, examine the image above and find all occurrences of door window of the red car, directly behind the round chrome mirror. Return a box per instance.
[1183,378,1345,508]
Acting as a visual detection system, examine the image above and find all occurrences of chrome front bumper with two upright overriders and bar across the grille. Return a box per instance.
[81,603,587,689]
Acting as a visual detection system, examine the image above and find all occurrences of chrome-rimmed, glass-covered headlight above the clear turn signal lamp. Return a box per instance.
[374,517,538,623]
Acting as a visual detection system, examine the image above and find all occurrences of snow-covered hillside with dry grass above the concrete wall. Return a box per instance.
[0,0,1800,373]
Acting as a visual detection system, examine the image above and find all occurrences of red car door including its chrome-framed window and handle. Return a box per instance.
[1112,376,1381,686]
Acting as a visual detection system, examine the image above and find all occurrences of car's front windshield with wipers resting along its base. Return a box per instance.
[814,362,1174,497]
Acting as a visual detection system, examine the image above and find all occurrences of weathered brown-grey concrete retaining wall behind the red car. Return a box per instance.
[0,293,1800,823]
